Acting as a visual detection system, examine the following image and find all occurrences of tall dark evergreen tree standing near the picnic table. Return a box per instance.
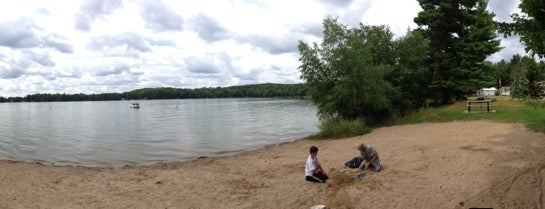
[414,0,500,104]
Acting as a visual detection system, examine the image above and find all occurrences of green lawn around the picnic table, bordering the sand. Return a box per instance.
[388,96,545,133]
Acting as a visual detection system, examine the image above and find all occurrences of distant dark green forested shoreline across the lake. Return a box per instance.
[0,83,307,102]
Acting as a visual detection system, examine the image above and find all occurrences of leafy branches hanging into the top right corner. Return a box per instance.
[499,0,545,58]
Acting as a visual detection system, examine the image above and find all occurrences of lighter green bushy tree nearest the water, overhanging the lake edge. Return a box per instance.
[298,17,397,125]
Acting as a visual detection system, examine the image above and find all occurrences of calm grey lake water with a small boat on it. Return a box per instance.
[0,98,319,166]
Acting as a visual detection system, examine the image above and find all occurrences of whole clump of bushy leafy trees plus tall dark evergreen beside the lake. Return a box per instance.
[298,0,500,133]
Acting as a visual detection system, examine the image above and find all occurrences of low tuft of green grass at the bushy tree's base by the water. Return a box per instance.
[314,119,371,138]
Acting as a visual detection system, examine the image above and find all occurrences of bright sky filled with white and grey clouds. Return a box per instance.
[0,0,525,97]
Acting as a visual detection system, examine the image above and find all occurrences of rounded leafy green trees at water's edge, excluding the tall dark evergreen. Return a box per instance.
[298,17,431,126]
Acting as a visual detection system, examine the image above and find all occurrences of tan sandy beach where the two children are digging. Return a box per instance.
[0,121,545,209]
